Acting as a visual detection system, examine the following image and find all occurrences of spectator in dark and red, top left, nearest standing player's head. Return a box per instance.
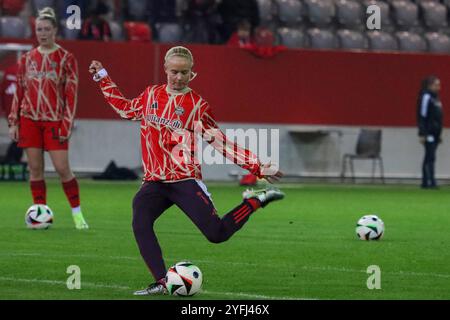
[80,1,111,41]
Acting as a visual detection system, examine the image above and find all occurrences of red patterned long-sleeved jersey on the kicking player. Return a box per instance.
[96,76,261,182]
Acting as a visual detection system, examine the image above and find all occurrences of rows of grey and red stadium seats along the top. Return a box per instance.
[0,0,450,53]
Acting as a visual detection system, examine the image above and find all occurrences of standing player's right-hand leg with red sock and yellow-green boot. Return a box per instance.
[49,150,89,229]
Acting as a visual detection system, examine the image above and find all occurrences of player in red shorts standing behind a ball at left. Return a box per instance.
[8,7,88,229]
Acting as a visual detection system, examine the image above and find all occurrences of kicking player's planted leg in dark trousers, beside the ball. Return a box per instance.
[133,182,173,295]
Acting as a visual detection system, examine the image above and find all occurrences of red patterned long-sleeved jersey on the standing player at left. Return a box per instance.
[8,46,78,137]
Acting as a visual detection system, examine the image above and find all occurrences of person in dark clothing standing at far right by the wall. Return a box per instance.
[417,76,443,189]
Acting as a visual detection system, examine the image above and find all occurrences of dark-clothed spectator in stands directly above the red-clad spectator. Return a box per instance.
[217,0,259,40]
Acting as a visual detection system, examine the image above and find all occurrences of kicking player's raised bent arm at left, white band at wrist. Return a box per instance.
[89,60,147,120]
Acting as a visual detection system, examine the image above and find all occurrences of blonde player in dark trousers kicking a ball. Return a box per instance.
[89,47,284,295]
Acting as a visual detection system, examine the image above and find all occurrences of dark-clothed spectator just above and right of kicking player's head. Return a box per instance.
[184,0,222,44]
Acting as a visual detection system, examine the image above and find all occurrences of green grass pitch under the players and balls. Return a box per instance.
[0,180,450,300]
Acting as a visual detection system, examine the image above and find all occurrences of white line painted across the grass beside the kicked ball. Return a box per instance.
[0,277,306,300]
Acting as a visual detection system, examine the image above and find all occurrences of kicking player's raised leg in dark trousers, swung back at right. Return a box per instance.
[168,180,283,243]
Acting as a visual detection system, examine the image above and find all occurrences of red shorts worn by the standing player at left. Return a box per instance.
[18,117,69,151]
